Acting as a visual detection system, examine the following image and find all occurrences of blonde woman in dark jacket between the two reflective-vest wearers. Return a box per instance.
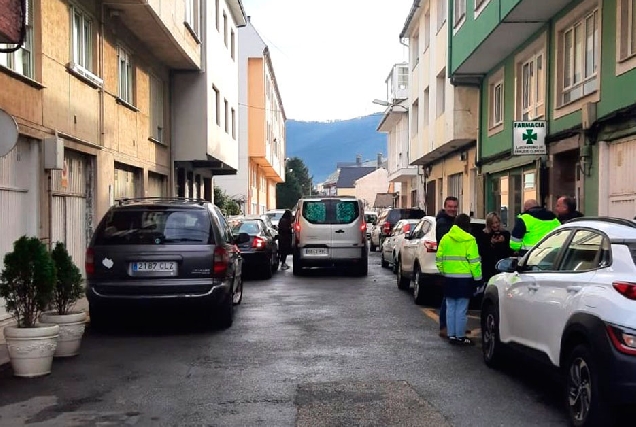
[476,212,512,283]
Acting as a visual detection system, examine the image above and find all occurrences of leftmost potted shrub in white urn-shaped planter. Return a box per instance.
[0,236,60,377]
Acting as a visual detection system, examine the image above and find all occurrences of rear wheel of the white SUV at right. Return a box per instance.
[565,345,612,427]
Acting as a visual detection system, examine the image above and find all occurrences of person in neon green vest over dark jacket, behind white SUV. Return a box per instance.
[510,199,561,256]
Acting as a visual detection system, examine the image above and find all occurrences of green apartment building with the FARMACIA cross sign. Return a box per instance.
[449,0,636,224]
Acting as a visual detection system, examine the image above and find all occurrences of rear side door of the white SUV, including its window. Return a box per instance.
[534,230,610,362]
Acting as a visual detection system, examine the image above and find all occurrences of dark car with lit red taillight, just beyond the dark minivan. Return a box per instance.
[232,217,278,279]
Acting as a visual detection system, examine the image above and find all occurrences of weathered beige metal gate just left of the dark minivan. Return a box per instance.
[51,149,93,272]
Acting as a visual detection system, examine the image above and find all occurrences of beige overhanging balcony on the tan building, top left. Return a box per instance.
[105,0,201,70]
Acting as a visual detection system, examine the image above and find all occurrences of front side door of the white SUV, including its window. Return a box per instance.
[500,230,572,348]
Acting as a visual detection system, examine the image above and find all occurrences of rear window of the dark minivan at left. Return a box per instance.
[95,209,213,245]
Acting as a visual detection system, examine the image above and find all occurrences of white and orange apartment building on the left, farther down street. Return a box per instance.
[215,17,287,214]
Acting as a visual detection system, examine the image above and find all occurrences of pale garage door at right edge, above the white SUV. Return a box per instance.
[608,140,636,219]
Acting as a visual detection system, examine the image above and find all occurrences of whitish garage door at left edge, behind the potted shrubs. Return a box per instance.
[0,139,39,320]
